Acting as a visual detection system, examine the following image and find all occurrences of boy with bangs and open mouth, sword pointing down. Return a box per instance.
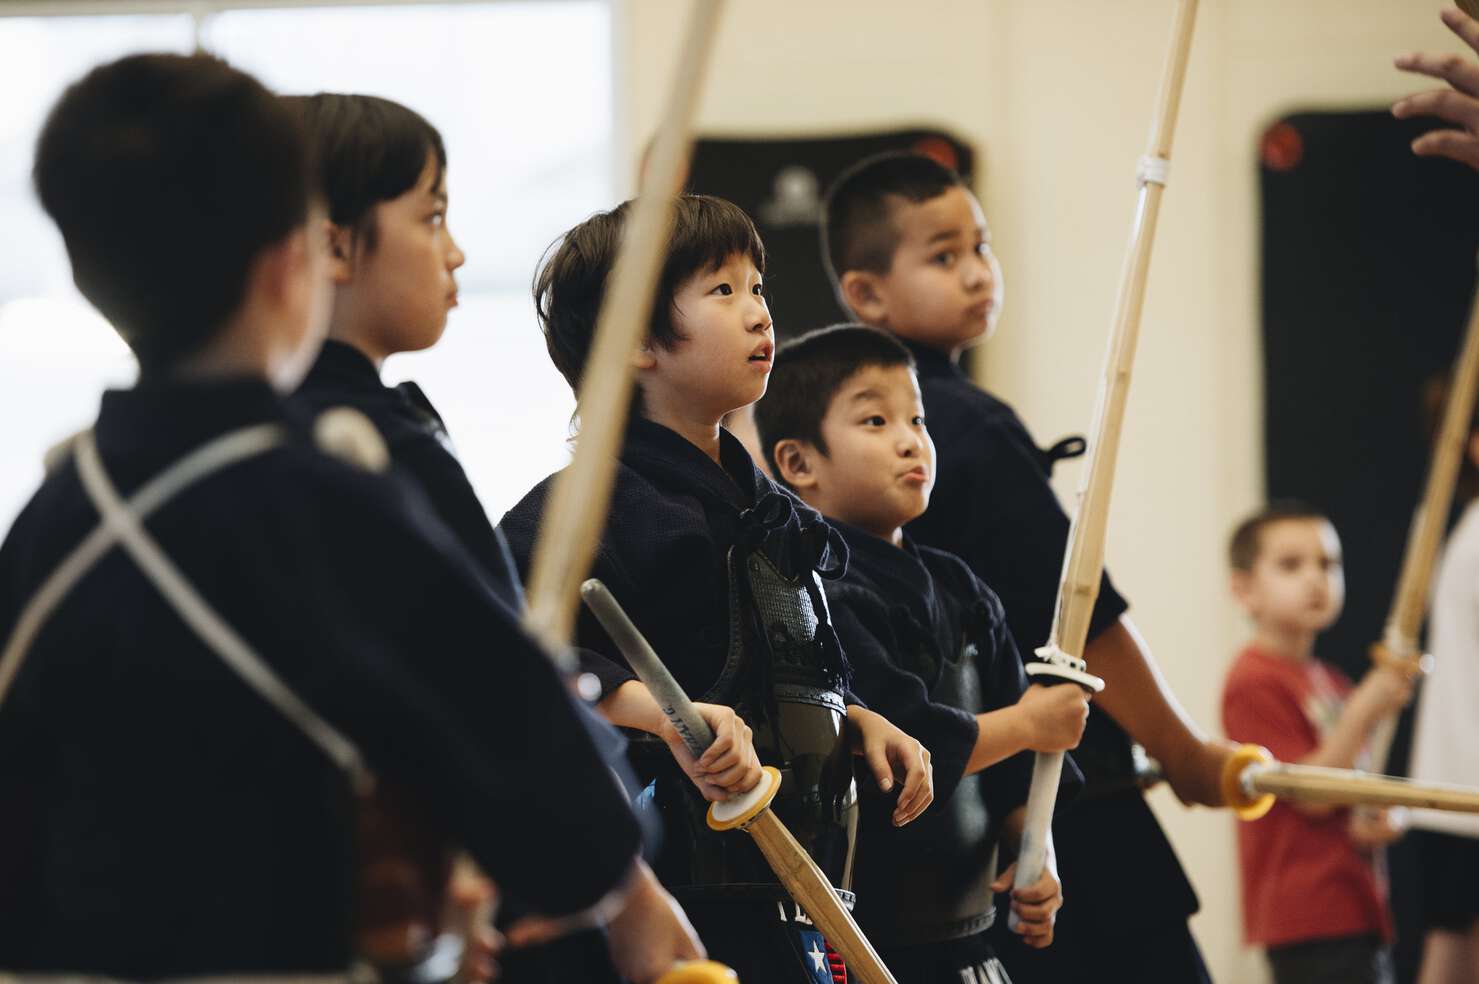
[501,195,930,981]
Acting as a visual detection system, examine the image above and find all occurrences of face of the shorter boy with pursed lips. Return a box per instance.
[782,365,935,543]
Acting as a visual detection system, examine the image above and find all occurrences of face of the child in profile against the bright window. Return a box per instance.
[334,155,466,358]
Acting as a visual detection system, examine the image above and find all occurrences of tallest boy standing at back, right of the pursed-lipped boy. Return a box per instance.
[824,154,1226,983]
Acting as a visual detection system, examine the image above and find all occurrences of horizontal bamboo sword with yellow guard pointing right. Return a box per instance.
[1222,744,1479,820]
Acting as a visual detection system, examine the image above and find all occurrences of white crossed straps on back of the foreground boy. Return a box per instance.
[0,423,374,793]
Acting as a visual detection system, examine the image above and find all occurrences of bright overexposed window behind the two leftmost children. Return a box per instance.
[0,0,614,525]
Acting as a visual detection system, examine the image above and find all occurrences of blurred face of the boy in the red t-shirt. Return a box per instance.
[1236,519,1346,632]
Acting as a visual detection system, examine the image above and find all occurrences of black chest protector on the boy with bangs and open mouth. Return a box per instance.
[633,493,858,903]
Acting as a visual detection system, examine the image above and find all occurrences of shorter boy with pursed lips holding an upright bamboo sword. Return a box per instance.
[756,324,1089,984]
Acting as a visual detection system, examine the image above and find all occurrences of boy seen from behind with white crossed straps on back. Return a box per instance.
[0,55,653,980]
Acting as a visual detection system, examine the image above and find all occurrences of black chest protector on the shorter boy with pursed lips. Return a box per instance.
[858,597,1001,946]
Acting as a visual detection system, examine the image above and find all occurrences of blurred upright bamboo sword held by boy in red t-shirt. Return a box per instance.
[1368,272,1479,771]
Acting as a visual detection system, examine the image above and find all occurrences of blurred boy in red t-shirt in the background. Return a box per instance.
[1222,505,1411,984]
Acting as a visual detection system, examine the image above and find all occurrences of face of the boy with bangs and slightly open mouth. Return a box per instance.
[639,253,775,425]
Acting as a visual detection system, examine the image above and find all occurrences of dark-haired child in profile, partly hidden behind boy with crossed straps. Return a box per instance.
[293,93,701,984]
